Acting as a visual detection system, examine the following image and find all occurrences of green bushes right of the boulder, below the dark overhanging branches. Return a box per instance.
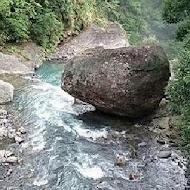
[168,49,190,154]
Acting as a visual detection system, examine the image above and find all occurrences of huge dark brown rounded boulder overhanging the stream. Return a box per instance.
[62,46,170,118]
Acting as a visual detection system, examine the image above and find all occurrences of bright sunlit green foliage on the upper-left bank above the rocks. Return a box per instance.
[0,0,117,48]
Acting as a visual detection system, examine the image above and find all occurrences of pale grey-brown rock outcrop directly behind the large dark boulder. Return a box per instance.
[49,22,129,63]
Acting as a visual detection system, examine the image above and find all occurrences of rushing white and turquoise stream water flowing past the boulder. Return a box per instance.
[0,64,186,190]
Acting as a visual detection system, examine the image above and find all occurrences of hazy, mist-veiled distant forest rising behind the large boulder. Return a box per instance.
[110,0,176,58]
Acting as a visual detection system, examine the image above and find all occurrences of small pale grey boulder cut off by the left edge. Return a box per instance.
[0,80,14,104]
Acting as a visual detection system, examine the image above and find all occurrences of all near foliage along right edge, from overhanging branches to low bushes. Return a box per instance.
[163,0,190,153]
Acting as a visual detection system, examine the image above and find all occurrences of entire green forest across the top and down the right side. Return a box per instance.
[0,0,190,154]
